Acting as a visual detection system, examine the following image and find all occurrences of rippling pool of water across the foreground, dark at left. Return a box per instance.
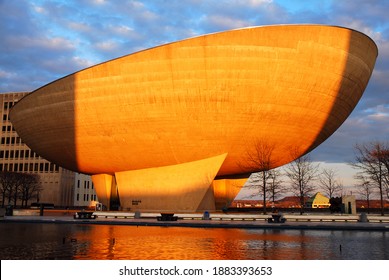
[0,223,389,260]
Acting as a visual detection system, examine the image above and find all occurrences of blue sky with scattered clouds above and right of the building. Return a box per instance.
[0,0,389,192]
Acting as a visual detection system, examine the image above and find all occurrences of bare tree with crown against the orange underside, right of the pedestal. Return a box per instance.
[240,140,275,214]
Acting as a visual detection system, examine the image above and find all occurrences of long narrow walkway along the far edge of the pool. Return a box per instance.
[0,213,389,231]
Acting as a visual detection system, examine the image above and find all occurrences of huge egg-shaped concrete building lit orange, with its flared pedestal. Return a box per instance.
[10,25,378,211]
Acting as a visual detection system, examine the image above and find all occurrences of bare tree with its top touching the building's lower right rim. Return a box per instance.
[286,155,319,214]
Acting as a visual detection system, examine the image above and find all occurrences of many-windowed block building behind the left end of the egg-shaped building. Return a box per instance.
[0,92,97,207]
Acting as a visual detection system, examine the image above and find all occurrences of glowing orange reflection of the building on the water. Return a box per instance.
[68,225,315,260]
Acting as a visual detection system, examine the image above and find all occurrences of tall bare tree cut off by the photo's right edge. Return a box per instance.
[350,142,389,216]
